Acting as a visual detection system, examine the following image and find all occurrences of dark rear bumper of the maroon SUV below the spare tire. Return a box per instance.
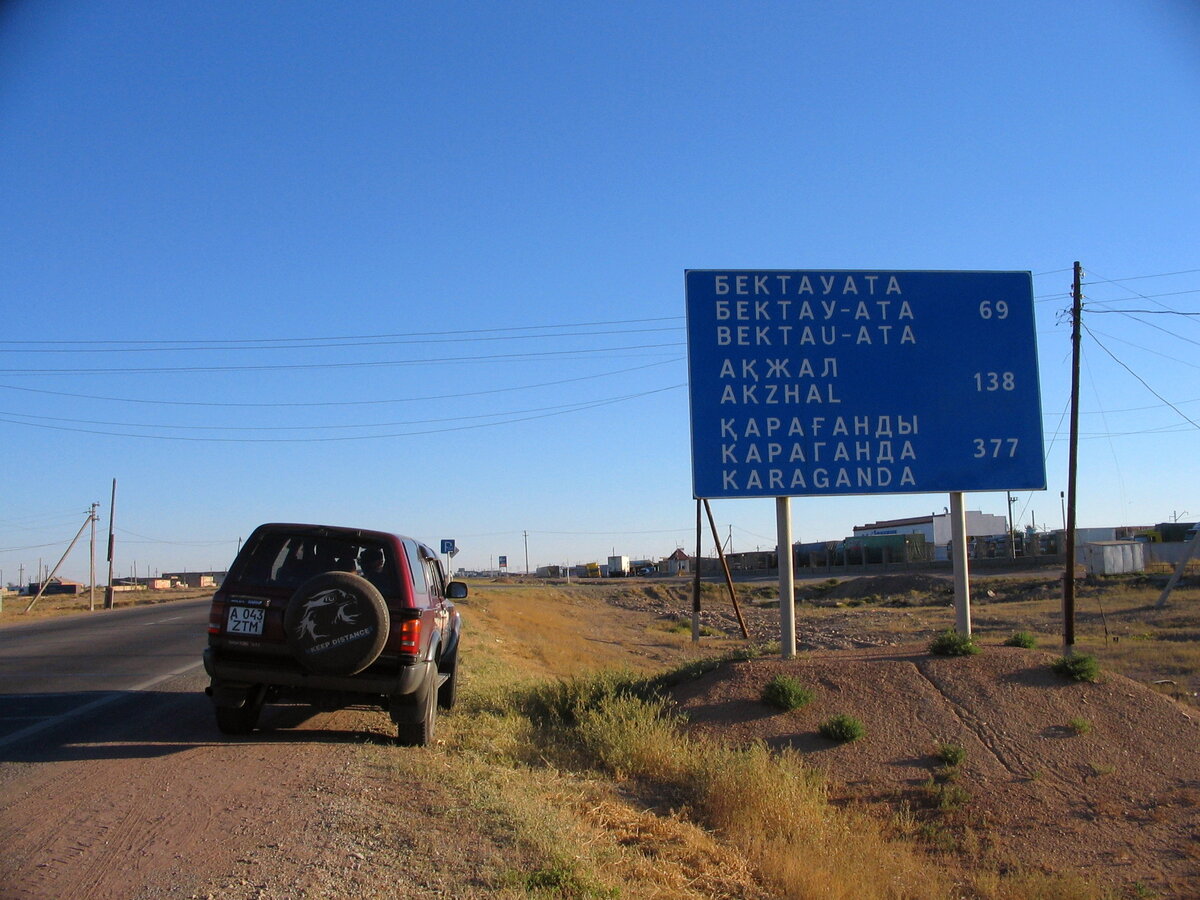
[204,647,433,697]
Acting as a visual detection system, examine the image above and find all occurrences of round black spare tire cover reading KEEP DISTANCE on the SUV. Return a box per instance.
[283,572,391,676]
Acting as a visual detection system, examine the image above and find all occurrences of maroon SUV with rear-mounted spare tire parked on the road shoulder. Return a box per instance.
[204,523,467,745]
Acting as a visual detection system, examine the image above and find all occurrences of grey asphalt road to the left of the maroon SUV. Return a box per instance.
[0,598,209,758]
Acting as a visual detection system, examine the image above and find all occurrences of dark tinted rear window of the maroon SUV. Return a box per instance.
[234,532,396,596]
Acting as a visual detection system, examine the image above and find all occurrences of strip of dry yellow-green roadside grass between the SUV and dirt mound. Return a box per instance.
[357,586,1161,900]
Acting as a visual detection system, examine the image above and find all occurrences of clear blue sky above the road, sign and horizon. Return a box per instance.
[0,0,1200,581]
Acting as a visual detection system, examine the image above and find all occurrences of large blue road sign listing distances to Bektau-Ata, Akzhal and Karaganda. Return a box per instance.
[684,270,1045,498]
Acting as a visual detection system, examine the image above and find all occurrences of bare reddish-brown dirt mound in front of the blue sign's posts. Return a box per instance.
[674,648,1200,896]
